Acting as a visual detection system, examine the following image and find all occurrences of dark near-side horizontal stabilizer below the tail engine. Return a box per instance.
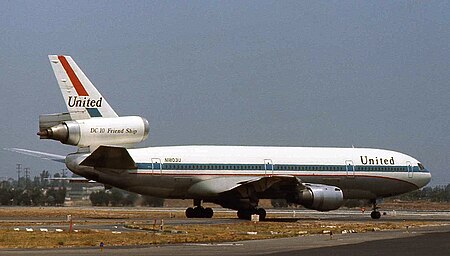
[80,146,137,169]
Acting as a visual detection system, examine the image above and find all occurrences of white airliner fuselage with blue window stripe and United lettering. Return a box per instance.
[67,146,431,199]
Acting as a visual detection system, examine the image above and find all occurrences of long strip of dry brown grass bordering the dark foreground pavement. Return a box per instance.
[0,221,436,248]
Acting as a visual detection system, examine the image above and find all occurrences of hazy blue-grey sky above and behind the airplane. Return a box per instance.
[0,1,450,185]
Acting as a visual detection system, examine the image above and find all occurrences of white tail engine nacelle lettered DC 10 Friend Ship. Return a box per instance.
[38,116,149,147]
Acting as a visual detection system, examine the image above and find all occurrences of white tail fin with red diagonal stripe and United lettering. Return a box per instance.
[48,55,118,120]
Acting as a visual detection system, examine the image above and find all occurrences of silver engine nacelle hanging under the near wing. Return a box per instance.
[295,184,344,211]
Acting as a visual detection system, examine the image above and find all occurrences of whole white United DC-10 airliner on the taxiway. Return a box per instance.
[13,55,431,220]
